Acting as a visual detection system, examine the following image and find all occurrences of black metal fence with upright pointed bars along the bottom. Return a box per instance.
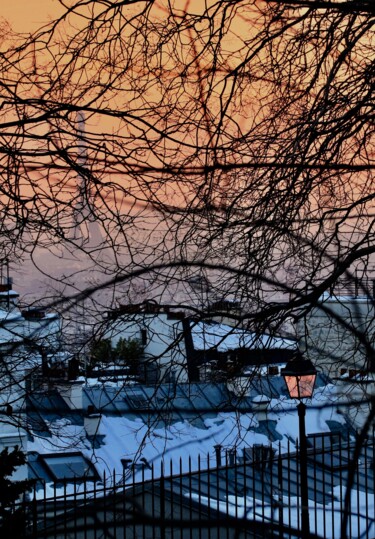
[8,433,375,539]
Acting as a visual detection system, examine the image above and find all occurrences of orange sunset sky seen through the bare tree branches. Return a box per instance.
[0,0,373,304]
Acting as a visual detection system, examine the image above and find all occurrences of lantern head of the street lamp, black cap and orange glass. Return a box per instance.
[281,359,317,399]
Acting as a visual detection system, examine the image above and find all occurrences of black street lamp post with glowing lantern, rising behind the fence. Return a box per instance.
[281,353,317,538]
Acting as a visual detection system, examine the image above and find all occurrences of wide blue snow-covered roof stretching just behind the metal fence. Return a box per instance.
[28,377,345,492]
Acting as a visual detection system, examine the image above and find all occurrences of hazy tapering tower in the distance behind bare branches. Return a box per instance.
[71,111,103,249]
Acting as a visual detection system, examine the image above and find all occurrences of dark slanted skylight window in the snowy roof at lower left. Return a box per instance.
[41,453,99,481]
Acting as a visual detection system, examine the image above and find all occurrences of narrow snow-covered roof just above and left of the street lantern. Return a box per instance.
[191,322,297,352]
